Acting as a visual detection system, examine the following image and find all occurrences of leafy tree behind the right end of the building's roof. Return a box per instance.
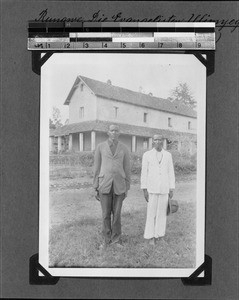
[168,83,197,108]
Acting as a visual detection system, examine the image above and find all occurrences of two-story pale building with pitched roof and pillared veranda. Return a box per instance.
[50,76,197,154]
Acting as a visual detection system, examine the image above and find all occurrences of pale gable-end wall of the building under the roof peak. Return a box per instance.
[69,84,96,124]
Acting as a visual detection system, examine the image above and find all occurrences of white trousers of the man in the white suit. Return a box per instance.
[144,194,168,239]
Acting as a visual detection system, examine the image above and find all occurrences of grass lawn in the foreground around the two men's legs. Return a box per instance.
[49,175,196,268]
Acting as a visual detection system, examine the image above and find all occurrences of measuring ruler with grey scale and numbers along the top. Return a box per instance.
[28,21,215,51]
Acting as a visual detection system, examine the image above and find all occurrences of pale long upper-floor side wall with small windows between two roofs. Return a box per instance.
[97,98,197,133]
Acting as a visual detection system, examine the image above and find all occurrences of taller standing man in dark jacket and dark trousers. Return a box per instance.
[93,125,130,247]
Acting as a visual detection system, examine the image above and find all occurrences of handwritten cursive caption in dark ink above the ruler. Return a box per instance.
[35,8,239,42]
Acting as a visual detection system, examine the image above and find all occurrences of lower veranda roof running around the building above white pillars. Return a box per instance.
[50,120,197,140]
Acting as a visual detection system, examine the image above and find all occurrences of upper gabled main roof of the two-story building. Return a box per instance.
[64,75,197,118]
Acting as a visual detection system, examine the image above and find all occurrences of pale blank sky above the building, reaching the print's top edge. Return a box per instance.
[41,52,206,124]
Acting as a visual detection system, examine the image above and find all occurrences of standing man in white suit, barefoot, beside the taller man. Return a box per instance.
[141,135,175,245]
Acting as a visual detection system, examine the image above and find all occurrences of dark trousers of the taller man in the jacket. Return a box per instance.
[100,185,125,243]
